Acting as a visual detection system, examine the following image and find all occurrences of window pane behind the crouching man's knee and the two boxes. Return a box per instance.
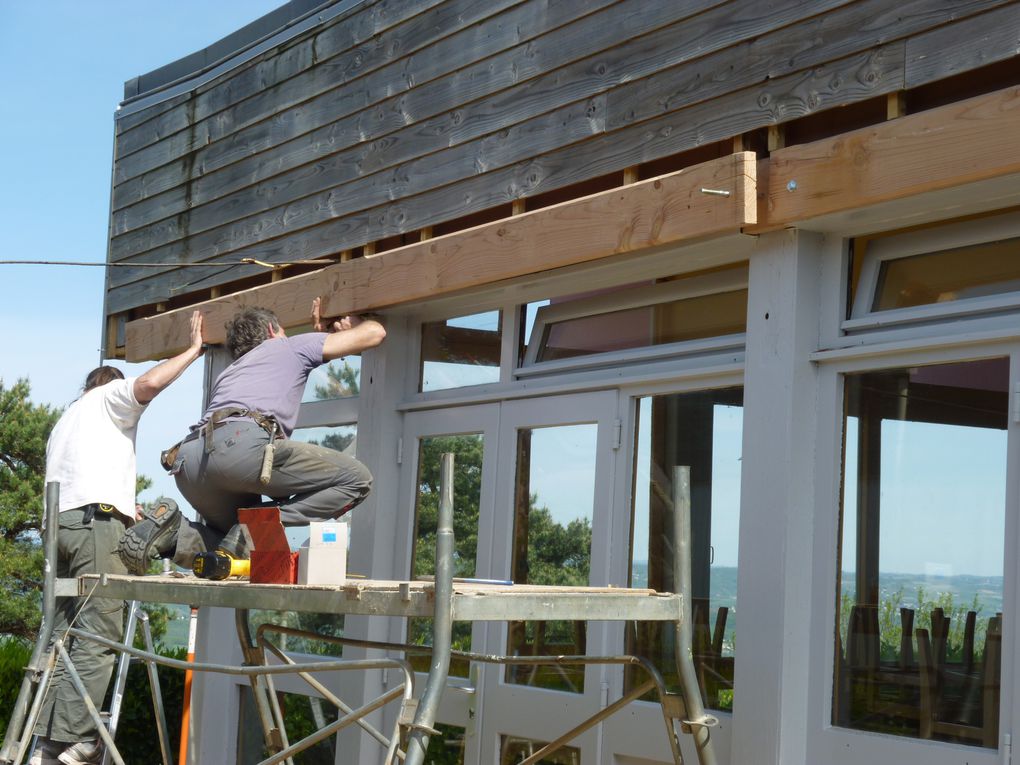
[251,425,358,656]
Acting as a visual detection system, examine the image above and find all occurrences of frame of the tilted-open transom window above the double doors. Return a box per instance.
[514,268,748,377]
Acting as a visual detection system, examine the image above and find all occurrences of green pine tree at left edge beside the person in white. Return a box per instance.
[0,379,60,639]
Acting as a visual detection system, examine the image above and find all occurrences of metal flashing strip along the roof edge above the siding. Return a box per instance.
[119,0,367,119]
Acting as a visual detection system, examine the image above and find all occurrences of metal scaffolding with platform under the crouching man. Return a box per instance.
[0,454,717,765]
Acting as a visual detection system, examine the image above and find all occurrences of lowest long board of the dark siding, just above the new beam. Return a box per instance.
[108,43,903,311]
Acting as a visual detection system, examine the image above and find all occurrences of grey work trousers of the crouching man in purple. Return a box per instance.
[172,419,372,566]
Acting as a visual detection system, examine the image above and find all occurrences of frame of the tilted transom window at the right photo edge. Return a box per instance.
[842,213,1020,333]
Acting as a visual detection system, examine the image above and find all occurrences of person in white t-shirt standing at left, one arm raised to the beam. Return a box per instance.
[29,311,203,765]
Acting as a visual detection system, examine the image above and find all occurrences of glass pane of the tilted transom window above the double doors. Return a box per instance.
[538,290,748,361]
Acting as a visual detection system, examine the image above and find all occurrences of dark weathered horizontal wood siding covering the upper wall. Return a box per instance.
[107,0,1020,315]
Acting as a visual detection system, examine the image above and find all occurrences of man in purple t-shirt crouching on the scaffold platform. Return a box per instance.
[120,299,386,573]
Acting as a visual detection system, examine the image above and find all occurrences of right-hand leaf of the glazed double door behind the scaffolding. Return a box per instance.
[477,392,619,763]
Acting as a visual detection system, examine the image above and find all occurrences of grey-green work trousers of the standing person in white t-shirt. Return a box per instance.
[35,510,128,744]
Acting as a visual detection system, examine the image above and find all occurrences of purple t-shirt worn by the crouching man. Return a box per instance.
[195,333,326,438]
